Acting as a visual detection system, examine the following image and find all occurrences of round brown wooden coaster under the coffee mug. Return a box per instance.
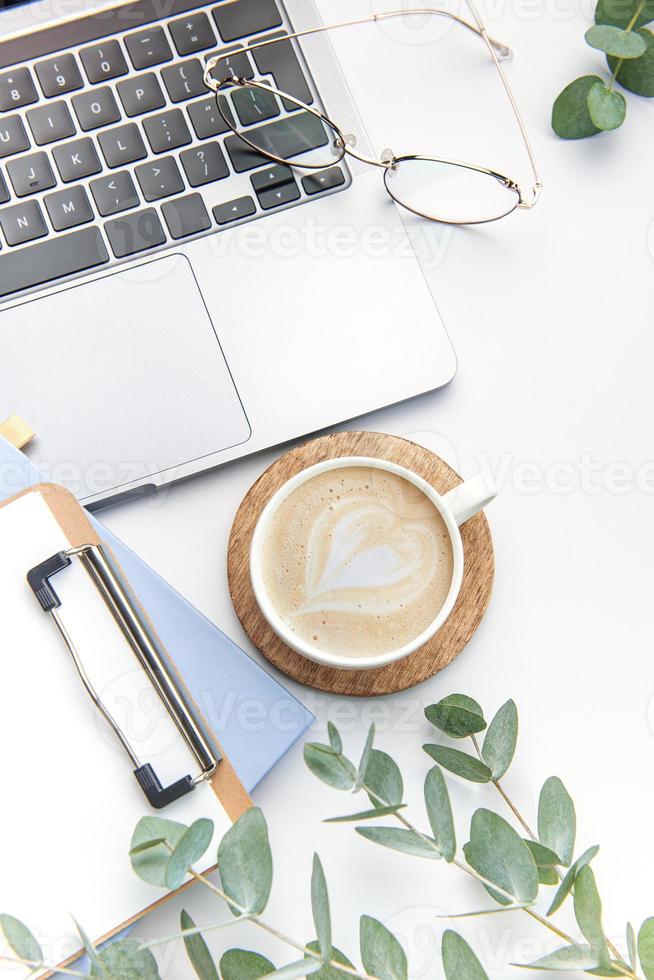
[227,432,495,697]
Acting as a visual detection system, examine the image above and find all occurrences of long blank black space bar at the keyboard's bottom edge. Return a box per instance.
[0,228,109,296]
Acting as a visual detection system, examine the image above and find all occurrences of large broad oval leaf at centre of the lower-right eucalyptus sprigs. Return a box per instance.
[464,808,538,905]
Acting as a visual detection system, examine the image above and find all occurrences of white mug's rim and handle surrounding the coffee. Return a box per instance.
[250,456,497,670]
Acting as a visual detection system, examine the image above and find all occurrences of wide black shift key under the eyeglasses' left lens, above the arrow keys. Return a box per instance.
[225,112,327,173]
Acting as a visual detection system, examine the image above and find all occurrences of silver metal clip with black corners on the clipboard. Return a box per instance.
[27,544,220,810]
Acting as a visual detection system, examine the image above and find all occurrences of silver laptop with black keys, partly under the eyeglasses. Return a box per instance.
[0,0,456,506]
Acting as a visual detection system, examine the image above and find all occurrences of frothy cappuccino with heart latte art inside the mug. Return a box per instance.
[261,465,453,658]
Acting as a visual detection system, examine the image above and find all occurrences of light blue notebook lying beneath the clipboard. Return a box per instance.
[0,437,313,792]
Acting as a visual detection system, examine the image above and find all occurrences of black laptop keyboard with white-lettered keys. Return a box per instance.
[0,0,347,297]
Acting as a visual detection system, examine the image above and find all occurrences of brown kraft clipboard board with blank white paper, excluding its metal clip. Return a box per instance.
[0,484,251,978]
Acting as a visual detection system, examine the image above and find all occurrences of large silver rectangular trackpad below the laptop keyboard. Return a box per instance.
[0,254,250,499]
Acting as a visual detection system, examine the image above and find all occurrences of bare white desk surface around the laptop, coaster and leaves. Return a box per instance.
[97,0,654,980]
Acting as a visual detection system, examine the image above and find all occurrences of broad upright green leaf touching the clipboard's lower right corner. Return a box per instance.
[218,807,272,915]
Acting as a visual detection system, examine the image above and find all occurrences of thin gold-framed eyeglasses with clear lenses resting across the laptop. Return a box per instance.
[204,0,543,225]
